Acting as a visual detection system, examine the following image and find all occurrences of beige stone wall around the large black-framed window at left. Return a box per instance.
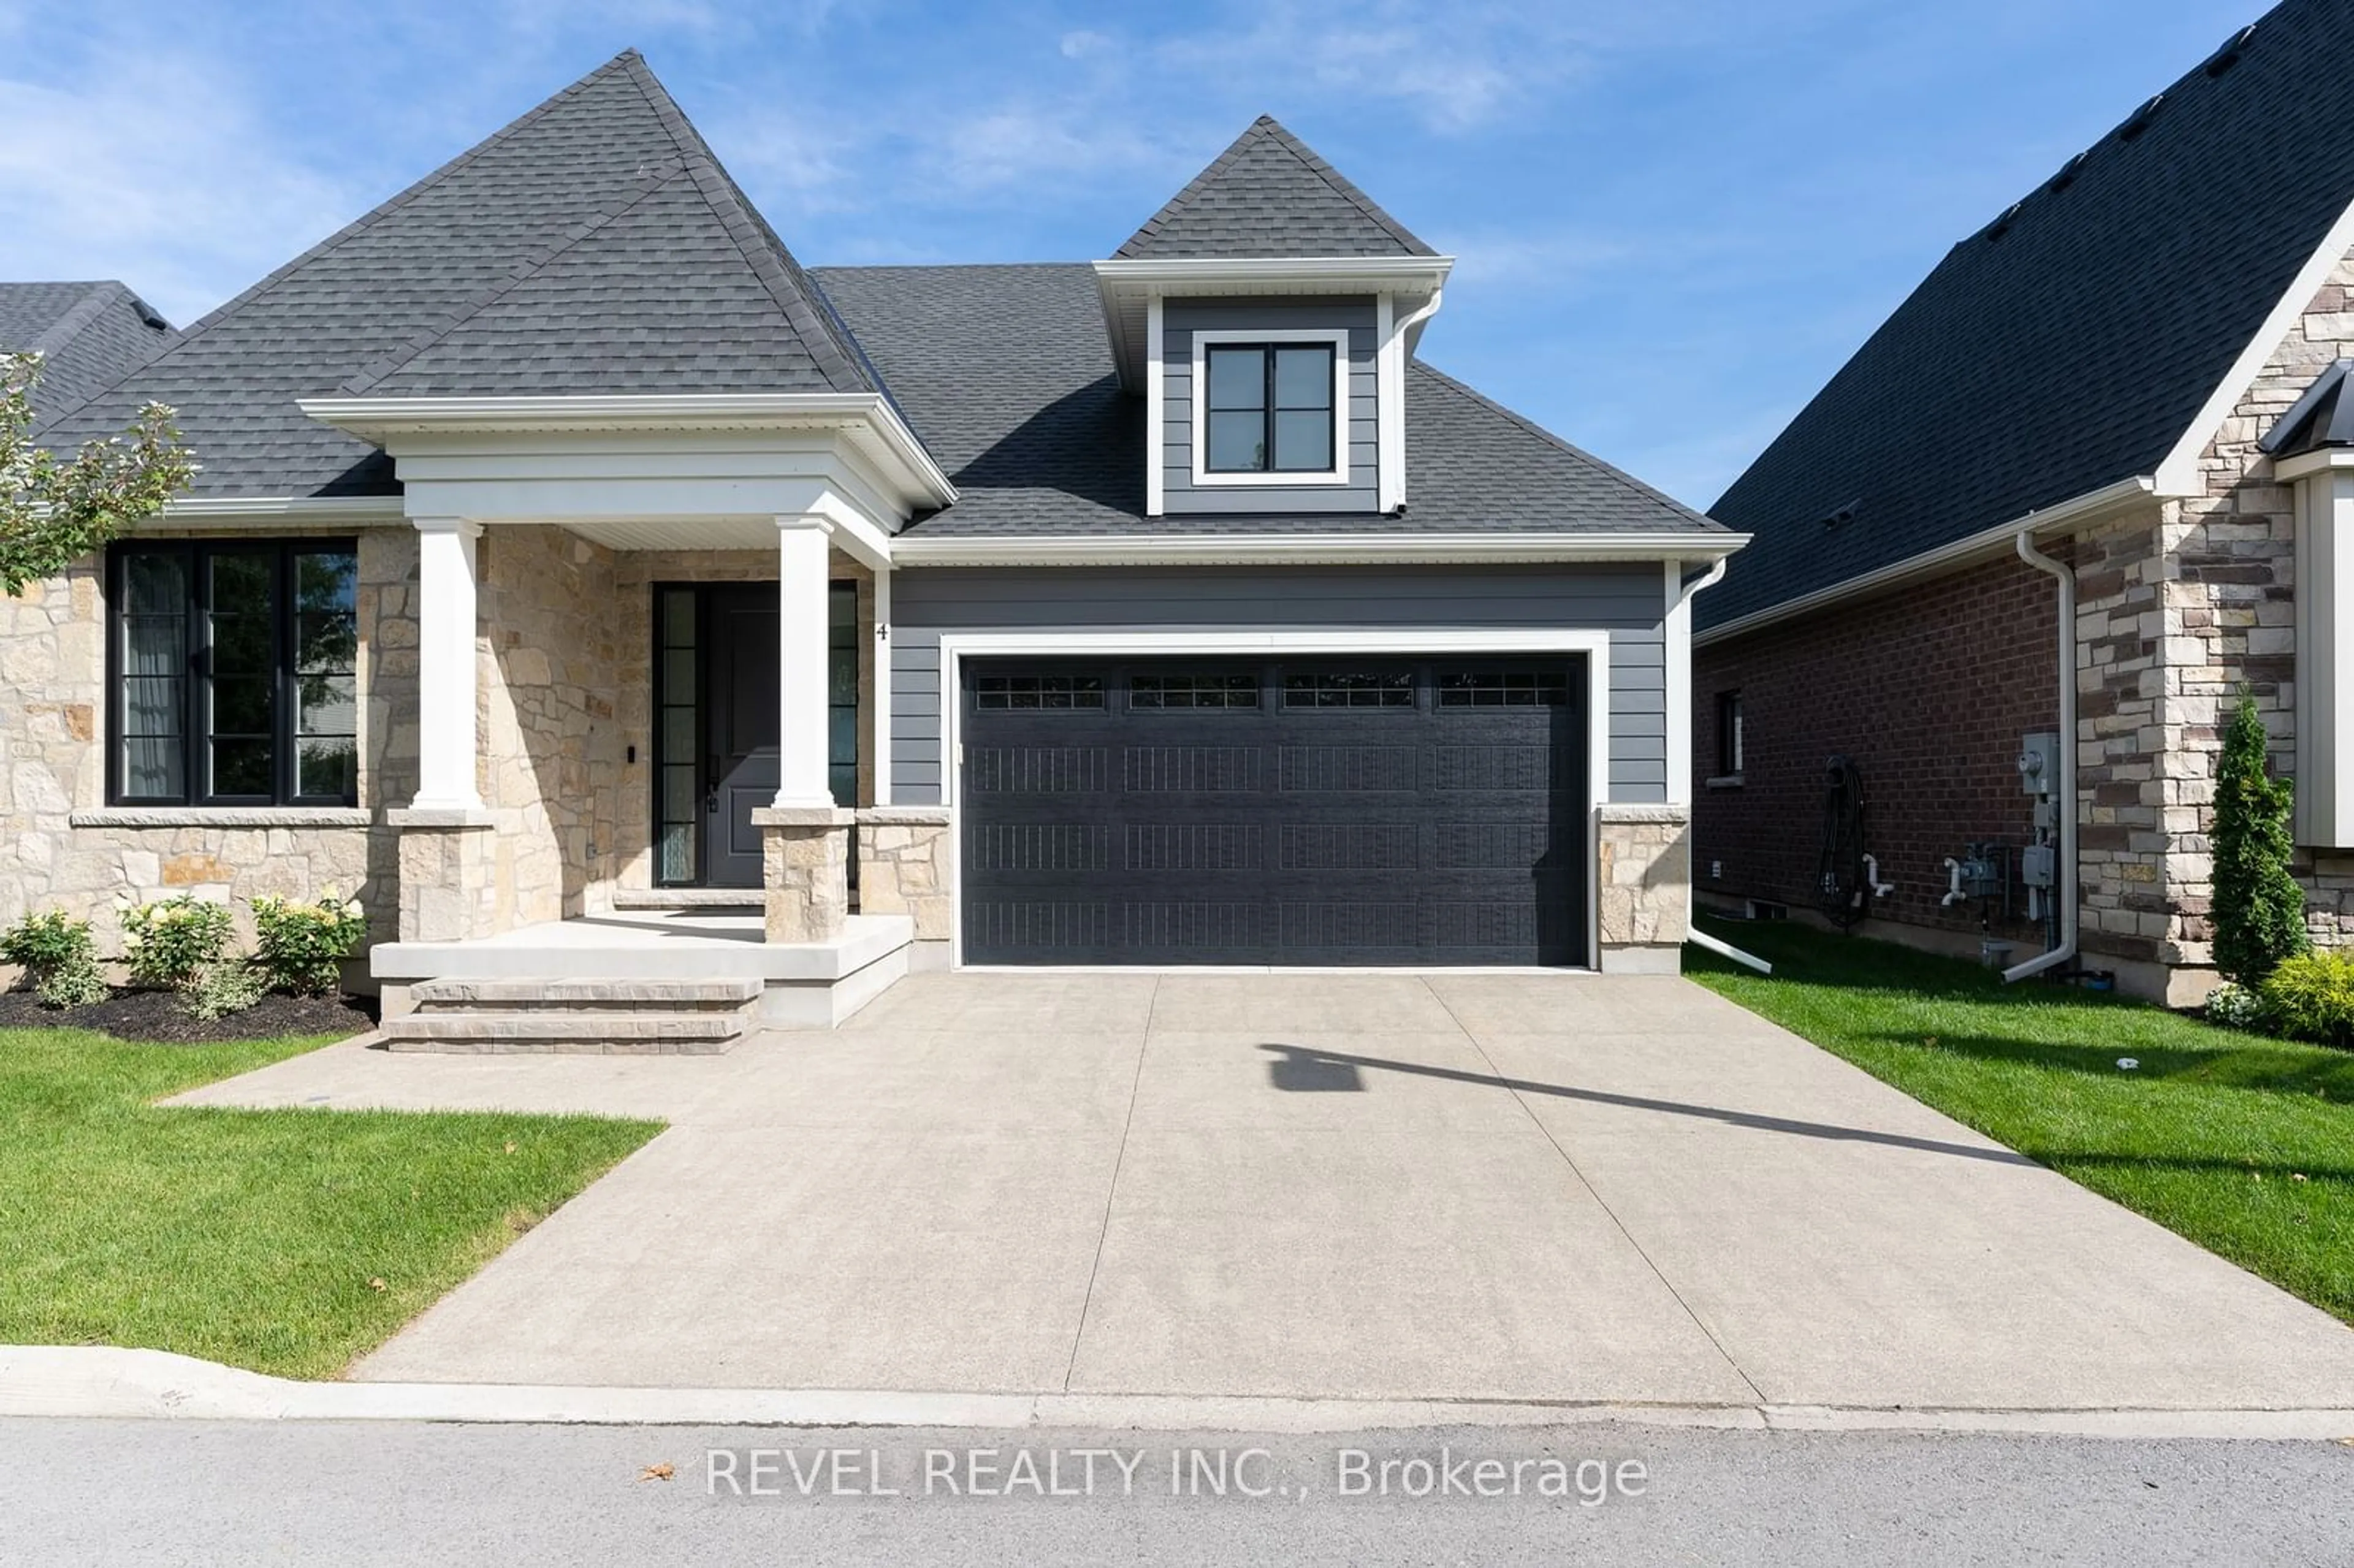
[0,527,417,954]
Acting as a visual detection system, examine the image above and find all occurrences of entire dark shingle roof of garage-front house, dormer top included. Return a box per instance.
[18,51,1714,535]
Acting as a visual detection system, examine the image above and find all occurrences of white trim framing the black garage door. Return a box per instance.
[939,626,1610,970]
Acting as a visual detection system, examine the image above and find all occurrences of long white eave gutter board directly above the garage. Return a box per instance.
[892,532,1749,568]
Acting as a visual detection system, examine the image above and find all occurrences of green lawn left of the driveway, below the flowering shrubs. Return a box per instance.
[0,1029,659,1377]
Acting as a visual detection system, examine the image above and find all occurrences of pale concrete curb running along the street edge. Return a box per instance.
[0,1347,2354,1441]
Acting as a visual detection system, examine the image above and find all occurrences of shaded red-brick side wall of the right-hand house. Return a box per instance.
[1693,558,2060,932]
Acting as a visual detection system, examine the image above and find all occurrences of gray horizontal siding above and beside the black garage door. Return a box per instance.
[890,565,1667,805]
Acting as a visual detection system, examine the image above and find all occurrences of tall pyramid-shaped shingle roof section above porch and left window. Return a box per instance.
[40,51,875,495]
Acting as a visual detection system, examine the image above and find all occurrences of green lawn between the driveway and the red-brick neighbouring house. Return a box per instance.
[1685,921,2354,1323]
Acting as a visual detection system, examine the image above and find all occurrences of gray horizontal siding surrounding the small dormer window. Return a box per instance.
[1160,299,1382,513]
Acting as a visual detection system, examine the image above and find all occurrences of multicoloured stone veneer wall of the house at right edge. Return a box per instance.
[2076,247,2354,1000]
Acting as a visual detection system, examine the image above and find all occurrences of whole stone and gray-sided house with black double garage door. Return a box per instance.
[0,51,1742,1048]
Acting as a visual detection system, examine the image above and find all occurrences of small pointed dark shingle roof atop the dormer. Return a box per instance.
[1113,115,1436,261]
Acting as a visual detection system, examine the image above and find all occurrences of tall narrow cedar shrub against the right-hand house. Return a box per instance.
[2213,695,2309,986]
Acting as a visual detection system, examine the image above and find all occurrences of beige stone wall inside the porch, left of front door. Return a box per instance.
[468,525,642,930]
